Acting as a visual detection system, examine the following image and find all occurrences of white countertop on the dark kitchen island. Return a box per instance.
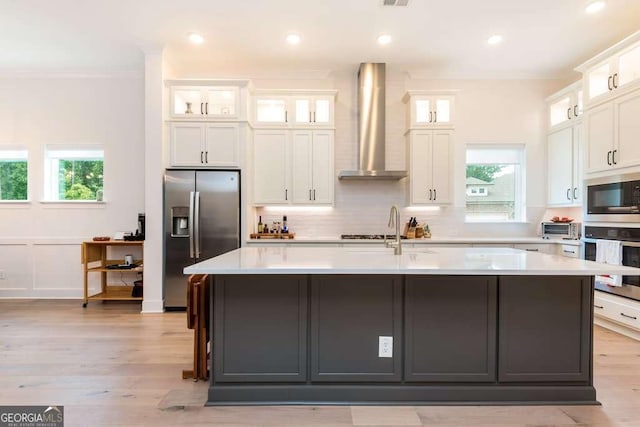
[184,246,640,276]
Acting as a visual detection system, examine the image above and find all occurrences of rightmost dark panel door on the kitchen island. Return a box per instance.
[498,276,593,382]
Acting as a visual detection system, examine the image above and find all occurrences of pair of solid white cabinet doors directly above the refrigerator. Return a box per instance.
[169,122,240,167]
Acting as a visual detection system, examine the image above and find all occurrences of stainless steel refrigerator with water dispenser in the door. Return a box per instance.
[164,169,240,310]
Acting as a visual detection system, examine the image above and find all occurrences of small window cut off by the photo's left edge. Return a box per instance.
[0,146,28,201]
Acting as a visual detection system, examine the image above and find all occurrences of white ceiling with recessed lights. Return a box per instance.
[0,0,640,78]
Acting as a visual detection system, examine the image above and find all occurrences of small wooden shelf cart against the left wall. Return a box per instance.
[82,240,144,307]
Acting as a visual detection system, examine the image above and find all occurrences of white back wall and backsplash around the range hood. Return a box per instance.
[249,71,563,237]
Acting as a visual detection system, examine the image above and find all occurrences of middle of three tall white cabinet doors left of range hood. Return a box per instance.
[291,131,313,203]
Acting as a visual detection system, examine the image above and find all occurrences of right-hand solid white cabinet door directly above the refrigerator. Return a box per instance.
[205,124,240,167]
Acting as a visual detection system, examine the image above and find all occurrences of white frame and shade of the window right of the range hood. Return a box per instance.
[464,143,527,223]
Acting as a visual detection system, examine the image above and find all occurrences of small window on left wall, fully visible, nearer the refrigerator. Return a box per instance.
[44,145,104,201]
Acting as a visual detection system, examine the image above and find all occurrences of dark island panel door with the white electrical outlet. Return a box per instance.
[310,275,402,382]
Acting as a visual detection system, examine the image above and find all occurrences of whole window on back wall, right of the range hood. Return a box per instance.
[465,144,526,222]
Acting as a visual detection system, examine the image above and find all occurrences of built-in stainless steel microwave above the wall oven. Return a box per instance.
[585,174,640,222]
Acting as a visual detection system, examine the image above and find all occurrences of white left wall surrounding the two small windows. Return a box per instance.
[0,74,145,298]
